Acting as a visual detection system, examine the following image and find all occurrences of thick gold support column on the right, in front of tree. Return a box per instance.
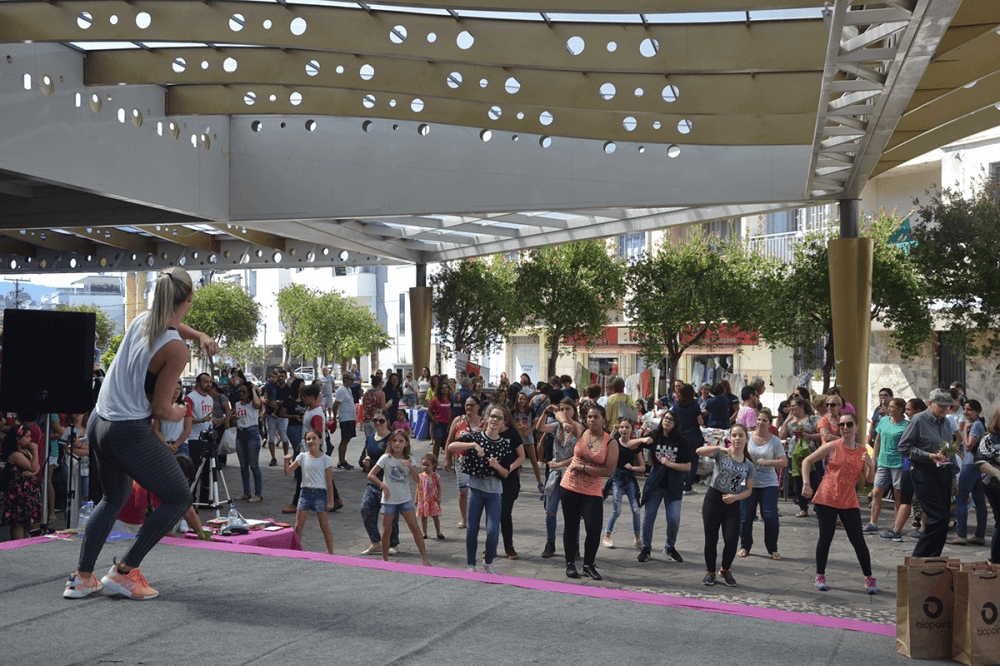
[827,200,875,412]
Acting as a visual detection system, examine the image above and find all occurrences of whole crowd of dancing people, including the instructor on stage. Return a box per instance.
[0,270,1000,599]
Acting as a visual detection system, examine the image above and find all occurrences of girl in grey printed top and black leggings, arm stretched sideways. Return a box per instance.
[695,423,755,587]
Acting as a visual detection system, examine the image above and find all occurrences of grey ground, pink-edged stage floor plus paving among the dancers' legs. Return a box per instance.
[0,430,992,664]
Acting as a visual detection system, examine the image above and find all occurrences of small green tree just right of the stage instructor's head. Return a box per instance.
[184,282,260,375]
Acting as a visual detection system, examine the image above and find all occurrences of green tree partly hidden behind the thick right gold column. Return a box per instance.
[758,211,932,391]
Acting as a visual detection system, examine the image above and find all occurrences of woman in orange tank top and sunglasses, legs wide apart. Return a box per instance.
[802,414,878,594]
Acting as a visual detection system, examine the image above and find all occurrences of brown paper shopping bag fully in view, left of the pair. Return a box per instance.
[896,559,955,659]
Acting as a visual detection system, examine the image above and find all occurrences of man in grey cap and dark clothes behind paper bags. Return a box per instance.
[898,389,956,557]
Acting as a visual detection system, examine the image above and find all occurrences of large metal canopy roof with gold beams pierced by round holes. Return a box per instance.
[0,0,1000,272]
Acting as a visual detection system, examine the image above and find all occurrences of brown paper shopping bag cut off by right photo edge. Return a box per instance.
[951,563,1000,666]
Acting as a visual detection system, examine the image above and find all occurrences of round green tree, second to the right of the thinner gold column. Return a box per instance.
[514,240,625,376]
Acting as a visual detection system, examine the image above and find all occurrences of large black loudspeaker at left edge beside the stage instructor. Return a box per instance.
[0,310,97,414]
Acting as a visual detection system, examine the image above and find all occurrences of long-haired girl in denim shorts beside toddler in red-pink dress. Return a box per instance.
[368,430,431,567]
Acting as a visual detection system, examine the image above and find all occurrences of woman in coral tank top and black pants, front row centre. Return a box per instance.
[559,405,618,580]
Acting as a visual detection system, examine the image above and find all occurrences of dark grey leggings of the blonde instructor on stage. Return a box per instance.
[77,415,191,572]
